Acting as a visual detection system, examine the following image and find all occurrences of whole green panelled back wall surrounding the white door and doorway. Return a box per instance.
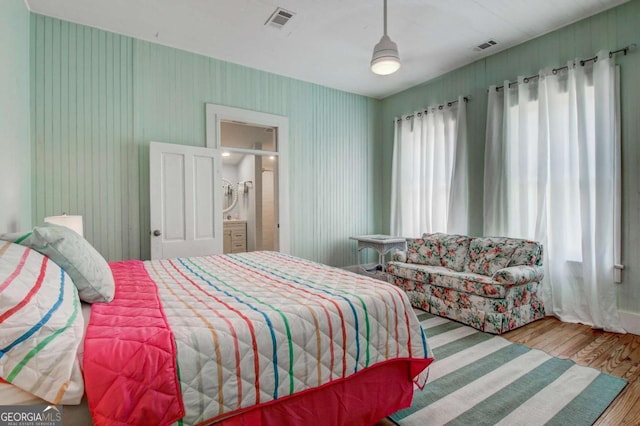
[31,14,382,266]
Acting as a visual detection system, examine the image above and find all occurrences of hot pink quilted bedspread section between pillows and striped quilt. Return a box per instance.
[84,261,184,425]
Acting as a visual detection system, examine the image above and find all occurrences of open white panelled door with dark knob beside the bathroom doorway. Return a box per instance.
[149,142,222,259]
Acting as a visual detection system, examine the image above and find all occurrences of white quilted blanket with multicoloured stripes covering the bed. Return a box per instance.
[85,252,431,424]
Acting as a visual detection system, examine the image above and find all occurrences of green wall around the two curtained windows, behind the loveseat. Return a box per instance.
[382,0,640,313]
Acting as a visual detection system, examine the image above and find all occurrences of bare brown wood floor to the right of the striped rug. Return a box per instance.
[376,317,640,426]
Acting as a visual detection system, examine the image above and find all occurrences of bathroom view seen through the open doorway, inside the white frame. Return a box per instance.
[220,120,279,253]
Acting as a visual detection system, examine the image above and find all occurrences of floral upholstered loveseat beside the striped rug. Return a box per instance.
[386,233,544,334]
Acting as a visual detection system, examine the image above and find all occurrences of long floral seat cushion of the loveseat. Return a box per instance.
[387,262,508,298]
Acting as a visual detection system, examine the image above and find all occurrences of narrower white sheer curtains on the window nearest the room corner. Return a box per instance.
[391,97,469,237]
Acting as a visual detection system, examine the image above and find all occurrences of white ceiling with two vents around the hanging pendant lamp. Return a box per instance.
[25,0,628,98]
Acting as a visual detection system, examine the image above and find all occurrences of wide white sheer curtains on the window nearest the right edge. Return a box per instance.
[484,52,624,332]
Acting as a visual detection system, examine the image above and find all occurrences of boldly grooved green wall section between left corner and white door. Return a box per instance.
[31,14,133,260]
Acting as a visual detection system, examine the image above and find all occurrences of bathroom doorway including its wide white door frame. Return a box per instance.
[206,104,291,253]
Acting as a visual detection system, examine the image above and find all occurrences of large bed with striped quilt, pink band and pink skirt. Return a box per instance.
[0,225,432,425]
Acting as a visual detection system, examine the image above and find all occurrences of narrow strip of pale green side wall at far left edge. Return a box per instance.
[0,0,31,233]
